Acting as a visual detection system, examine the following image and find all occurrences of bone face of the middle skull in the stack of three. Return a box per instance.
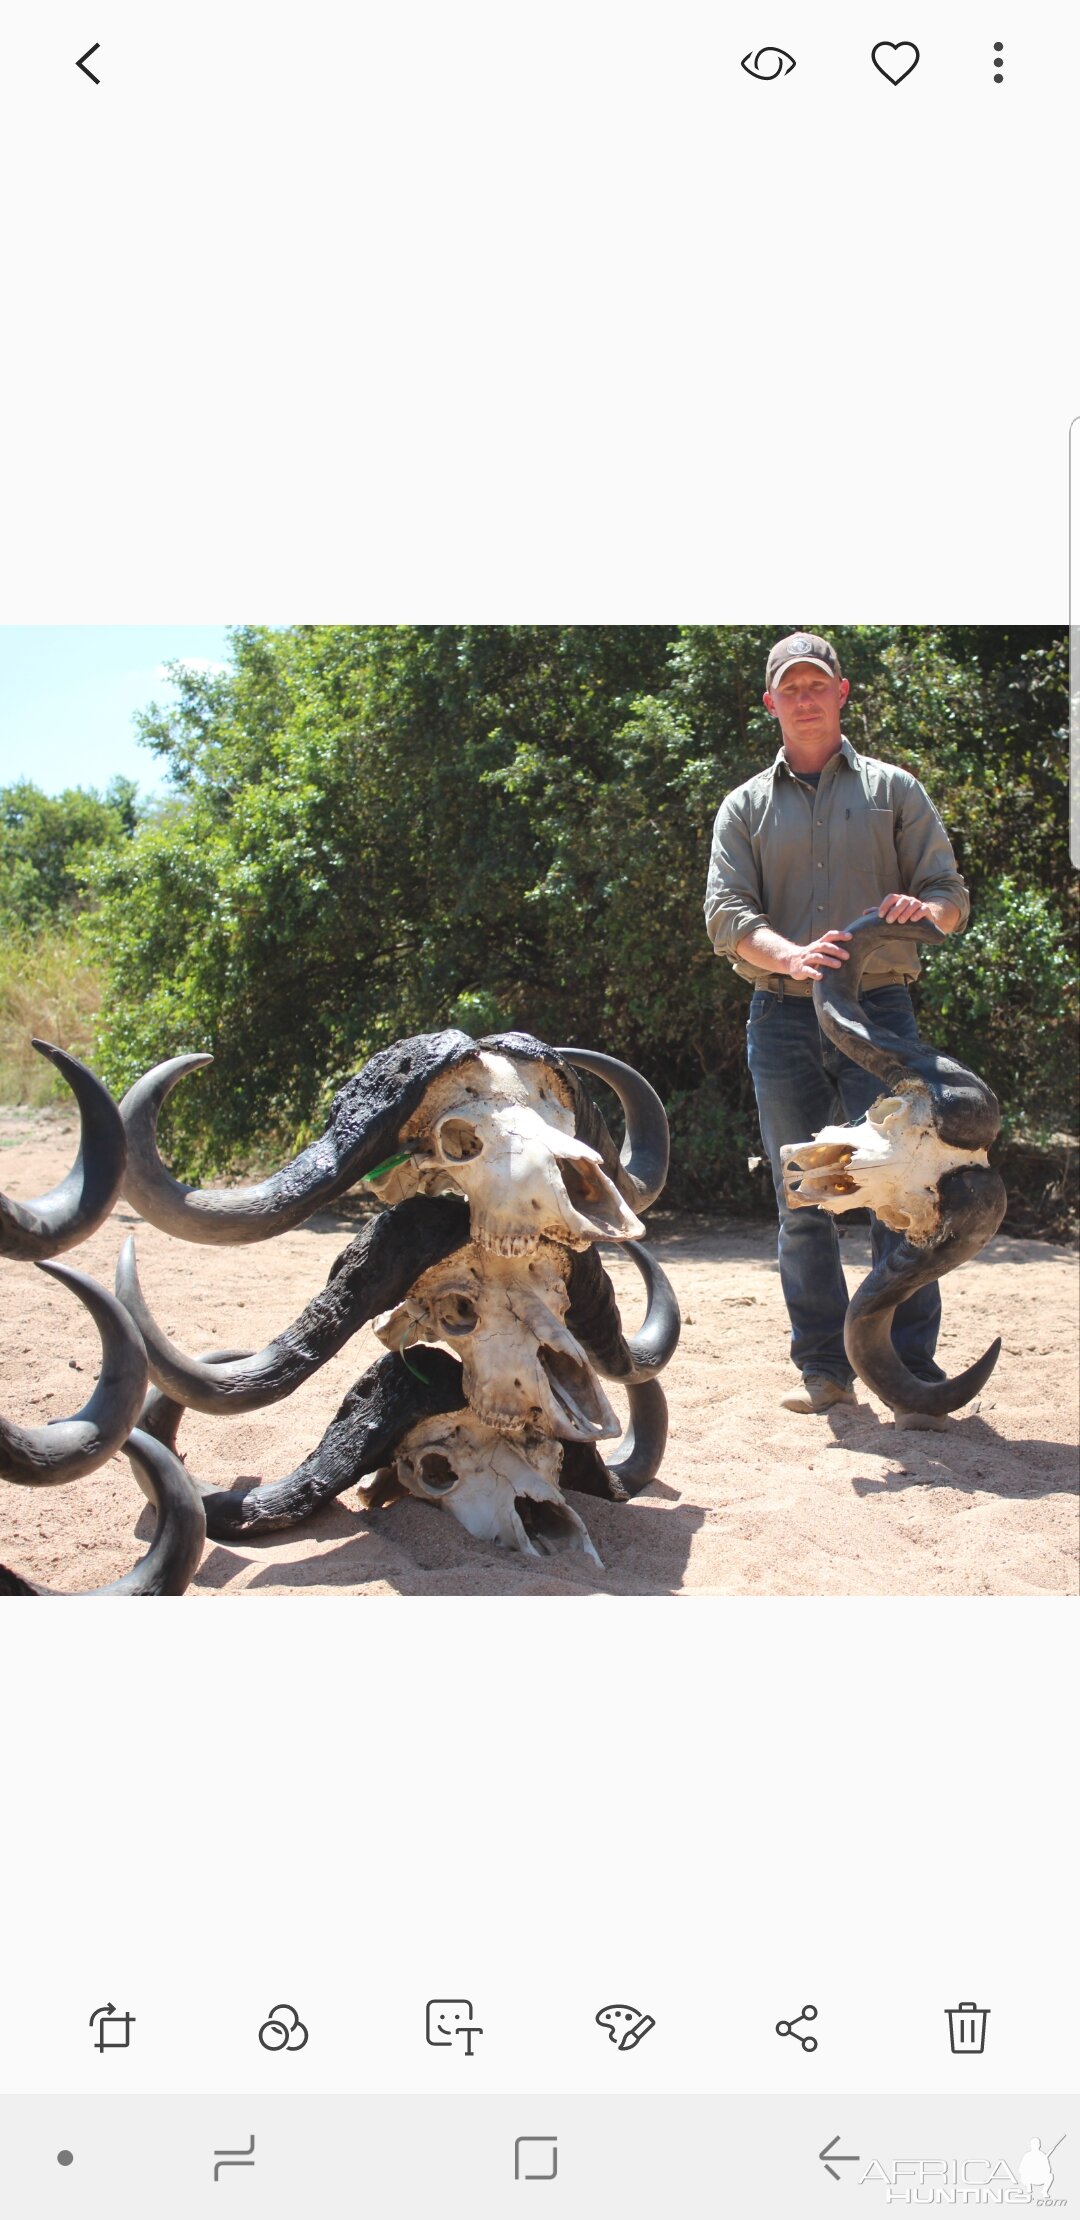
[376,1241,620,1441]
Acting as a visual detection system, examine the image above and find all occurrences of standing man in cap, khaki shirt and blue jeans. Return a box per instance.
[704,633,969,1425]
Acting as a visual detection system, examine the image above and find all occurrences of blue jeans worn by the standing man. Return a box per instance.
[747,986,944,1385]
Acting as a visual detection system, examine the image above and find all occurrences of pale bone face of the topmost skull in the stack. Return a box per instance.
[373,1050,644,1257]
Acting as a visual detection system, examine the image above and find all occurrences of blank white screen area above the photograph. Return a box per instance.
[0,0,1080,624]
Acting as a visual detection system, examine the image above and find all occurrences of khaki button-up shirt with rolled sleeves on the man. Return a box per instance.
[704,739,971,988]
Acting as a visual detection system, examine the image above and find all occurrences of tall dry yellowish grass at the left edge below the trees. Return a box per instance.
[0,924,102,1108]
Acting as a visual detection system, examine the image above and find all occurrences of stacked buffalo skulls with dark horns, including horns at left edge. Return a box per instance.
[0,1032,680,1594]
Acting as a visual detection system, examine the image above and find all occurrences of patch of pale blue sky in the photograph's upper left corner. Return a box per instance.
[0,624,229,795]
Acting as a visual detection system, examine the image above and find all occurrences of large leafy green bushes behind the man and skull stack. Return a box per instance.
[67,613,1076,1208]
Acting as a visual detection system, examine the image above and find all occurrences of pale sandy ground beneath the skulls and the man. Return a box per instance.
[0,1112,1078,1596]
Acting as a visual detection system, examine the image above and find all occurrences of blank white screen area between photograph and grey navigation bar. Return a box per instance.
[0,1596,1076,2096]
